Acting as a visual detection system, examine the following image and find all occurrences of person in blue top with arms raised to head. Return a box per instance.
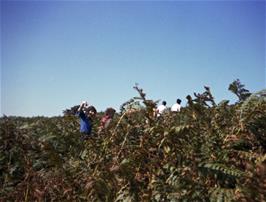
[77,101,97,139]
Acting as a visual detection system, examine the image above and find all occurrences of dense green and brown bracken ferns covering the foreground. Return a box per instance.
[0,81,266,202]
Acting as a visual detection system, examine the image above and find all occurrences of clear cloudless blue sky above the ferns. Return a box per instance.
[1,1,266,116]
